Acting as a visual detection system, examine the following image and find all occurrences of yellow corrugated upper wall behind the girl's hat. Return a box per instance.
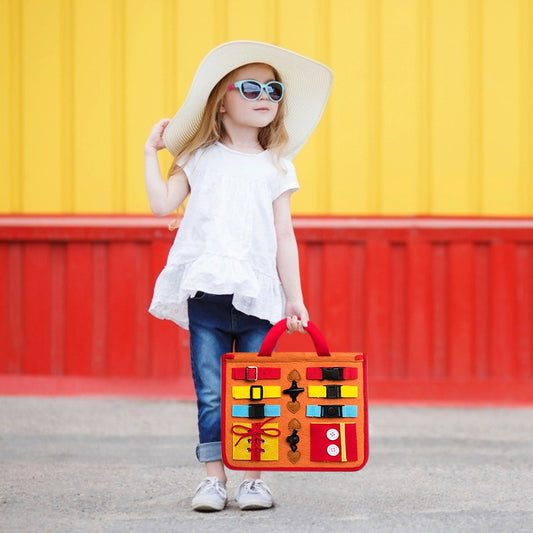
[0,0,533,215]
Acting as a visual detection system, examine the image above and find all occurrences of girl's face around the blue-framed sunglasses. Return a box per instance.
[219,63,279,129]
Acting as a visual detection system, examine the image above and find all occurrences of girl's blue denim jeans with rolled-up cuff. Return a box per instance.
[188,292,272,463]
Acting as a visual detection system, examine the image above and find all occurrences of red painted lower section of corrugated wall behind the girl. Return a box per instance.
[0,217,533,404]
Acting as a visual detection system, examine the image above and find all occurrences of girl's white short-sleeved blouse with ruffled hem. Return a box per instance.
[150,143,299,329]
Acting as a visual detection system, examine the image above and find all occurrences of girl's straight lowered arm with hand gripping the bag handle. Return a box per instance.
[273,191,309,333]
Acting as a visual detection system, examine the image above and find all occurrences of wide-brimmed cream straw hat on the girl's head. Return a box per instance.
[163,41,333,159]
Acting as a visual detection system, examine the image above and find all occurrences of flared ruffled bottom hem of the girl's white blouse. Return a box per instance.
[149,255,285,329]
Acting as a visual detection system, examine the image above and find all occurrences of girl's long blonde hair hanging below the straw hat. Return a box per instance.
[168,63,289,229]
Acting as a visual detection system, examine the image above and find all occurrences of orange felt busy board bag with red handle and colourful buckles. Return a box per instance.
[222,320,368,470]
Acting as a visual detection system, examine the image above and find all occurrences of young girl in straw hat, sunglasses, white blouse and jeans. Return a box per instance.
[144,41,332,511]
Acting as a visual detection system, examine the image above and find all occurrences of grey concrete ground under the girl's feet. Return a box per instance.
[0,397,533,533]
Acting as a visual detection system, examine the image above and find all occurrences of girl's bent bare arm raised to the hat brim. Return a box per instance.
[144,118,190,217]
